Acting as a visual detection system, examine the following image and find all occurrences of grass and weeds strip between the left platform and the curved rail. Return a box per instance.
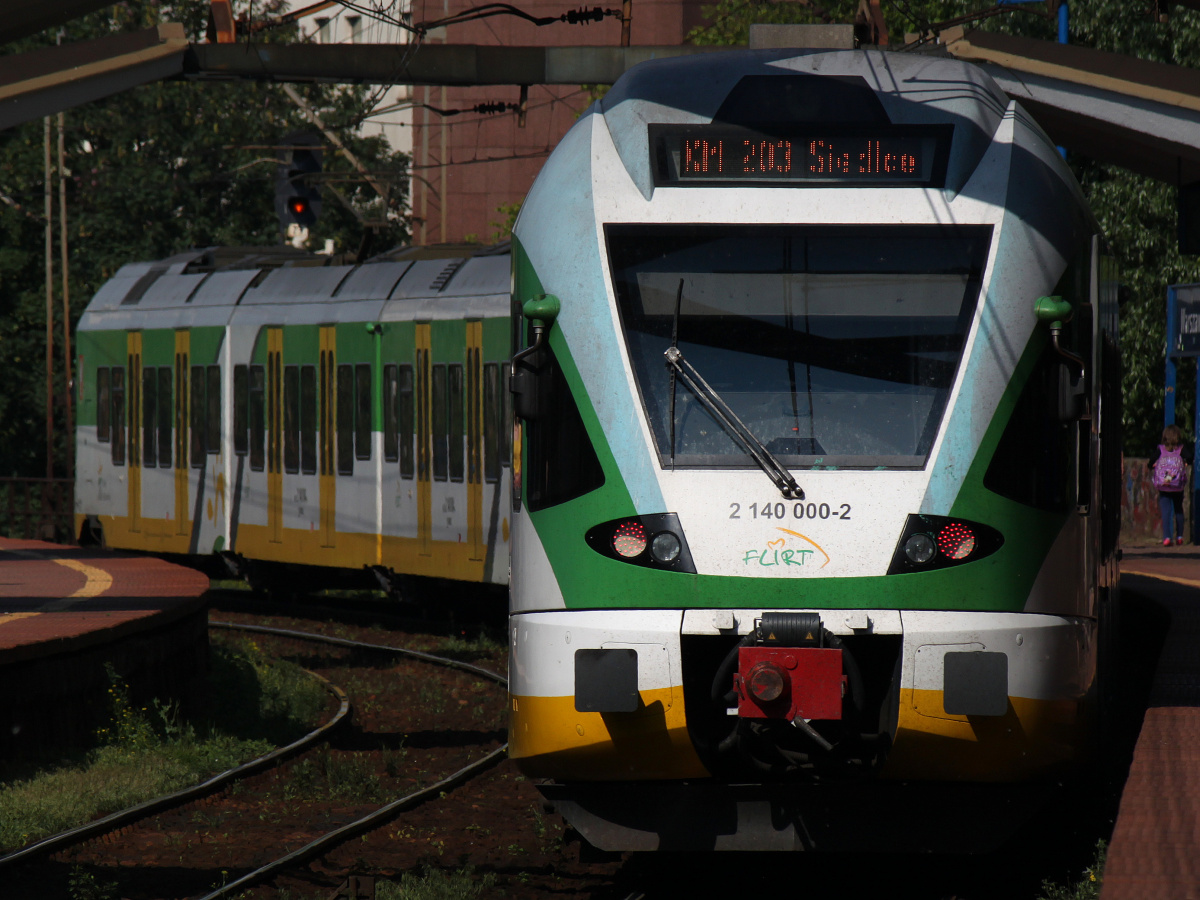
[0,642,326,852]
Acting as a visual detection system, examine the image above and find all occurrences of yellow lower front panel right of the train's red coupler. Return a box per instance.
[883,689,1088,781]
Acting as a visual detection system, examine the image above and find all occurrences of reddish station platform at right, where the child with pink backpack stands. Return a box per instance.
[1100,545,1200,900]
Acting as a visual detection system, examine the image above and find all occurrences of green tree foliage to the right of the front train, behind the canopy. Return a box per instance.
[689,0,1200,456]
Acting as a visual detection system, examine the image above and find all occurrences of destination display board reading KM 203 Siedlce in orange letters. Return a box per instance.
[649,125,954,187]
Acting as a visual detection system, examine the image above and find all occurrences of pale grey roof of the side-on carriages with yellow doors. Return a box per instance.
[79,242,510,330]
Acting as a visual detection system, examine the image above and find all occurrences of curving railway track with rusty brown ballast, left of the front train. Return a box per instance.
[0,592,1152,900]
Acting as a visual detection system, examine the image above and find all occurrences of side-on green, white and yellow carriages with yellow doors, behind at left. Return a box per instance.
[76,246,511,587]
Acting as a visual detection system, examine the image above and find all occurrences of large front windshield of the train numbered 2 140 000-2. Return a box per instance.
[606,224,991,468]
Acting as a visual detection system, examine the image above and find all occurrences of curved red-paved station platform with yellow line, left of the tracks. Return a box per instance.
[0,538,209,760]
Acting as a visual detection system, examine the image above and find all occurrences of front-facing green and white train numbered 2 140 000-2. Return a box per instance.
[509,49,1121,850]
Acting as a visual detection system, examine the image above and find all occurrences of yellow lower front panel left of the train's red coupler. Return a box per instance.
[509,688,708,781]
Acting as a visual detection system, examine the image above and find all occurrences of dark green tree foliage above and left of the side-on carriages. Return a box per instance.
[0,0,408,476]
